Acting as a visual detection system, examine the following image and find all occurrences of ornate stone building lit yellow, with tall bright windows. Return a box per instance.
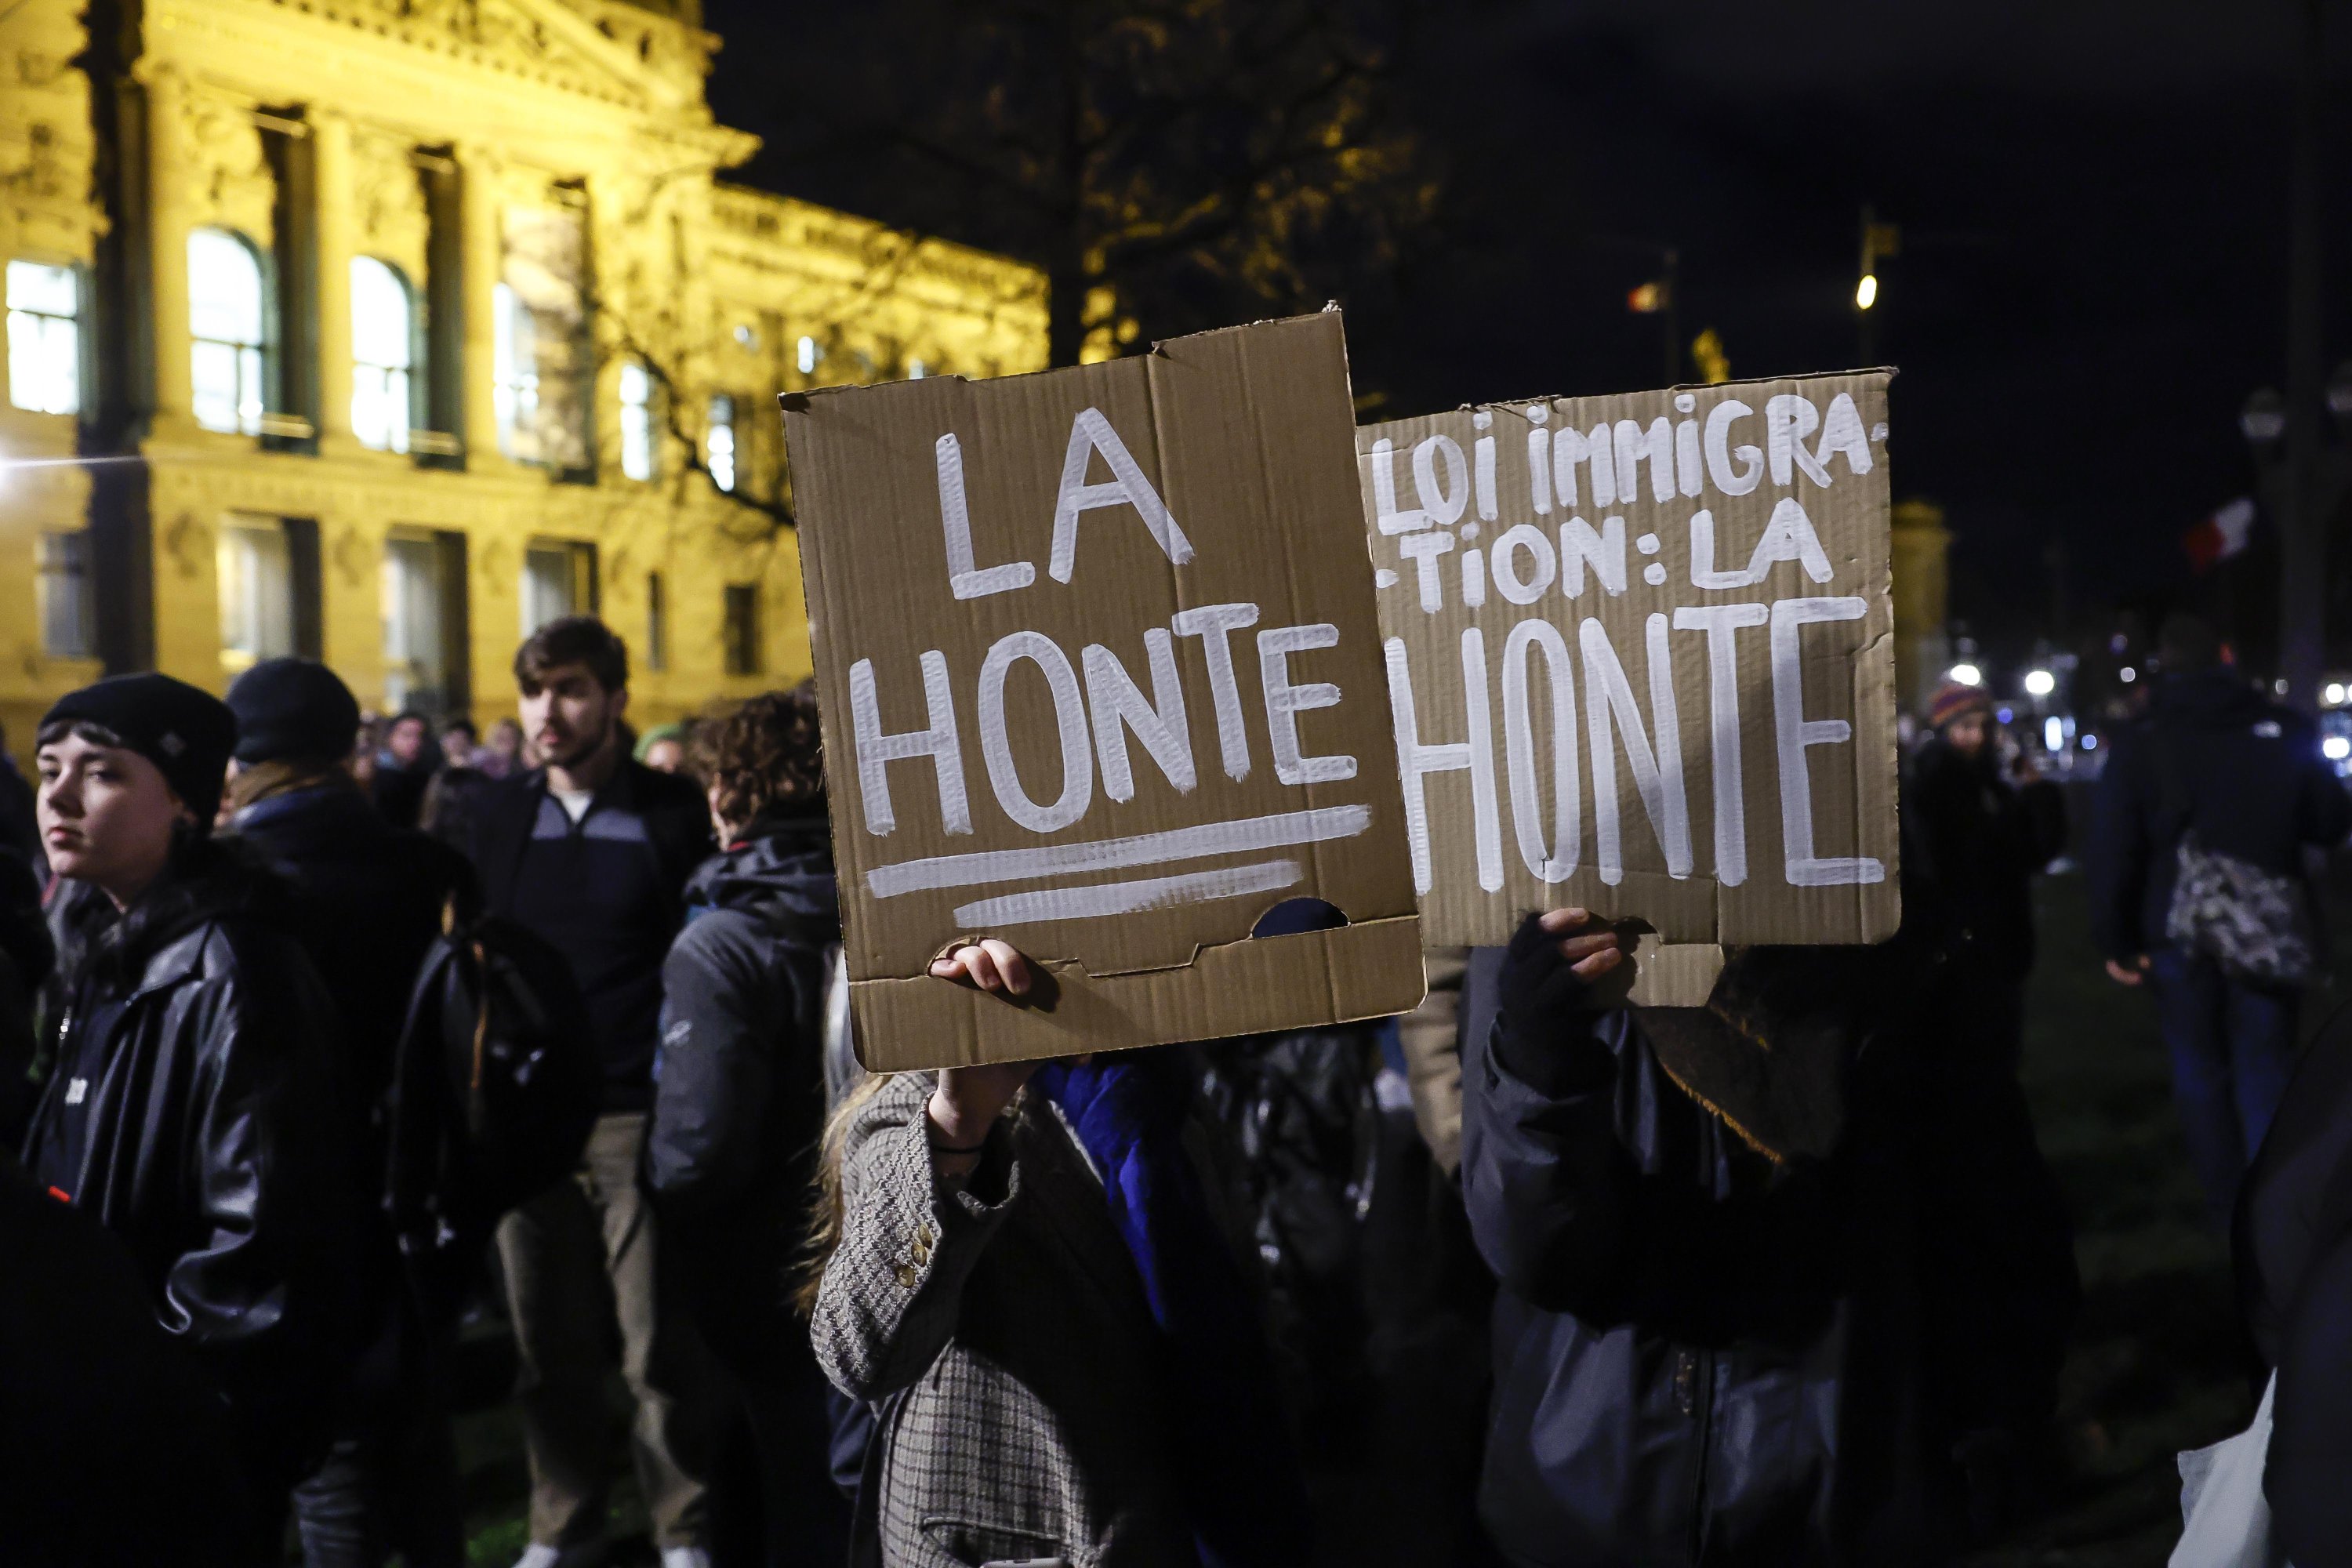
[0,0,1047,753]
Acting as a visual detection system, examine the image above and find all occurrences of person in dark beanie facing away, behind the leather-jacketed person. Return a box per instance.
[228,659,473,1568]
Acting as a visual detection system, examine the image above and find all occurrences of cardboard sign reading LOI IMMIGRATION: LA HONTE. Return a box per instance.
[1357,372,1900,949]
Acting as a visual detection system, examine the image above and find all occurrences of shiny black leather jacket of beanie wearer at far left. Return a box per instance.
[28,844,355,1497]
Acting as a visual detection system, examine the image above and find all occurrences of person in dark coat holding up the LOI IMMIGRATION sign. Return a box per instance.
[1463,909,2074,1568]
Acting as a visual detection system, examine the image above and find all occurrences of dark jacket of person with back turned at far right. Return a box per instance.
[2086,670,2352,959]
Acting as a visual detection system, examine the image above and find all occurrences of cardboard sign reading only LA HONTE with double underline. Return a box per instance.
[786,313,1423,1069]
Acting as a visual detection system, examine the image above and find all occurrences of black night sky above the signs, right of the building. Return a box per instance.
[708,0,2352,656]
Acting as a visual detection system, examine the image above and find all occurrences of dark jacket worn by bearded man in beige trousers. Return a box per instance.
[473,757,710,1112]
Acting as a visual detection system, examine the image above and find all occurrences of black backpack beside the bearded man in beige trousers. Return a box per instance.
[383,902,604,1305]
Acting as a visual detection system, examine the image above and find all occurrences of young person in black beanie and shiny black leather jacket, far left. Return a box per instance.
[24,675,355,1526]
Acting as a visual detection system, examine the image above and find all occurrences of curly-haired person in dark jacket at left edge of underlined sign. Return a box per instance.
[644,687,849,1568]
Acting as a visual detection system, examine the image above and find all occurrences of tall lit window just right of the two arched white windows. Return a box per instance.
[492,205,595,477]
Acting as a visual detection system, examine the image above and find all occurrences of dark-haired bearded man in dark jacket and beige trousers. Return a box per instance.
[473,616,715,1568]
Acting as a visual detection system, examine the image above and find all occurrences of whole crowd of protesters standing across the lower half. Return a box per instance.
[0,619,2352,1568]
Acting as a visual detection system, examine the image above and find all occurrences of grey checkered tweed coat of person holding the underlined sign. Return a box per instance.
[811,1072,1223,1568]
